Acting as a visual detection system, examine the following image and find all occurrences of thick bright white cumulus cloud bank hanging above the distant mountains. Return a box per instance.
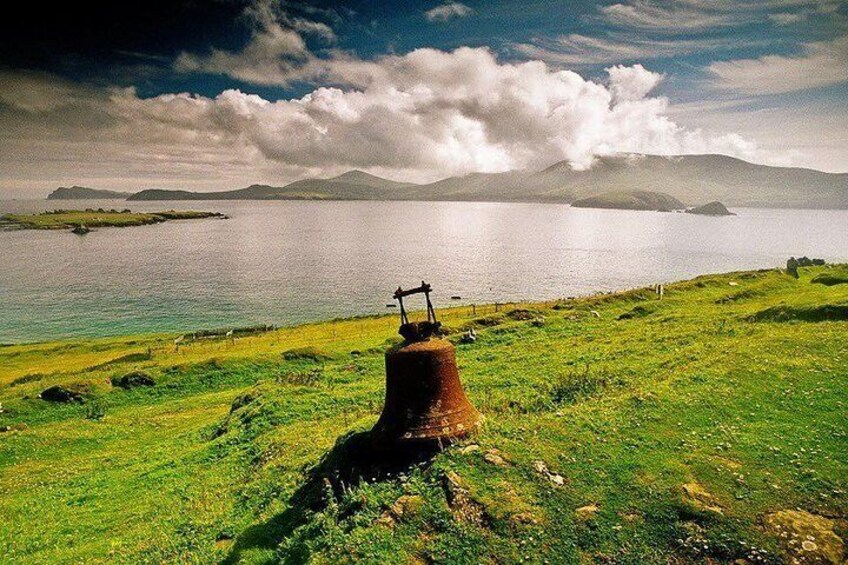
[0,47,780,192]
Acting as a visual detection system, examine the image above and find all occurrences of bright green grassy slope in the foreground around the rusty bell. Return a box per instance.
[0,268,848,563]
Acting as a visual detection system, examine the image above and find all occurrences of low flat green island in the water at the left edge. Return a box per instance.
[0,208,226,231]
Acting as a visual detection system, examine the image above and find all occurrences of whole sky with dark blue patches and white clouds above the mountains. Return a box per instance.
[0,0,848,195]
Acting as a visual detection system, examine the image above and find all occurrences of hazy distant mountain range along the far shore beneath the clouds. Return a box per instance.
[44,154,848,208]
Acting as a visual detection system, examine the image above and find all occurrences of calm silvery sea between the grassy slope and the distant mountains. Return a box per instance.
[0,201,848,343]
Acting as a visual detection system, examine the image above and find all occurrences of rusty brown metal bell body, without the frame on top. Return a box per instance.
[371,339,482,444]
